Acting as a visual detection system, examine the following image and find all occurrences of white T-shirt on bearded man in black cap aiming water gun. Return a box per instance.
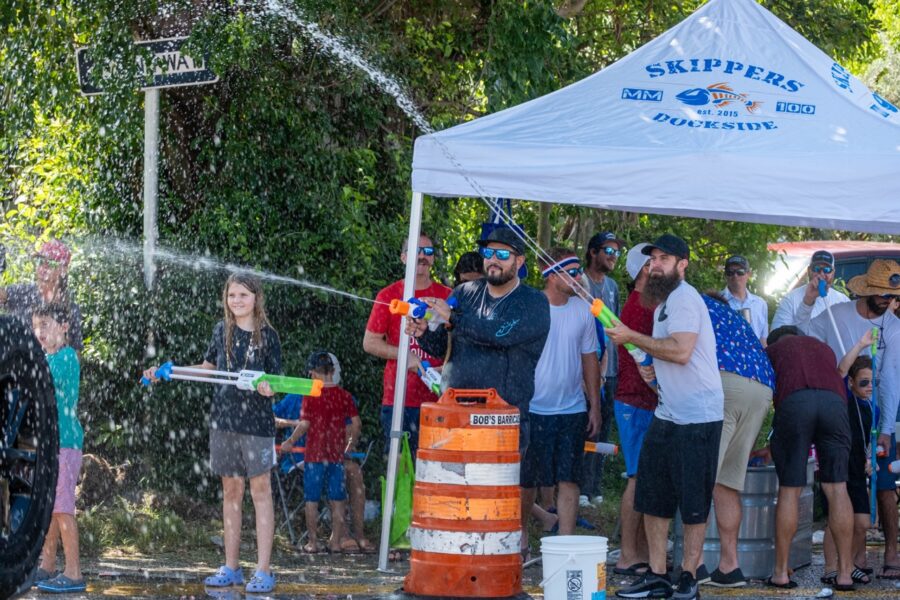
[653,281,725,425]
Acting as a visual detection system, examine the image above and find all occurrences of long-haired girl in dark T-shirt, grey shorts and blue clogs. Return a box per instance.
[144,273,281,593]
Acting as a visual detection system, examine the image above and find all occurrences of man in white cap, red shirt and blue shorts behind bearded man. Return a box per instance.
[613,244,659,575]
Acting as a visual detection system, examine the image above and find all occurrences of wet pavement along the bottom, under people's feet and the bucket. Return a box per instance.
[12,547,900,600]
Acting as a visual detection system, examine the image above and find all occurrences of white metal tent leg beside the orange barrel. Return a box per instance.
[378,192,422,572]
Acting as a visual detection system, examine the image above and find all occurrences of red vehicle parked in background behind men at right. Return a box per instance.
[763,240,900,299]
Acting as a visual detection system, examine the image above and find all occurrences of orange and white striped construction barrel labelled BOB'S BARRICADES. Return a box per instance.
[403,388,522,598]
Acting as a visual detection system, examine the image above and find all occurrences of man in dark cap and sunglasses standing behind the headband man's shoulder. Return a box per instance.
[580,231,625,505]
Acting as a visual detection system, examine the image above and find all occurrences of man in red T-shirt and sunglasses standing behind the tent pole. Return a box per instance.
[363,234,451,452]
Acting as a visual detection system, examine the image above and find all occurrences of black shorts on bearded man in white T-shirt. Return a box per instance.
[634,416,722,525]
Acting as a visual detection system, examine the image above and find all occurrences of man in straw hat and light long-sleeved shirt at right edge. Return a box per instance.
[809,259,900,579]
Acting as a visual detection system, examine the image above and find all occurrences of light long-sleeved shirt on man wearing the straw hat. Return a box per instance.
[809,302,900,435]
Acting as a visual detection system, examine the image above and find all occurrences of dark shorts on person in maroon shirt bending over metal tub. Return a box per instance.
[771,390,850,487]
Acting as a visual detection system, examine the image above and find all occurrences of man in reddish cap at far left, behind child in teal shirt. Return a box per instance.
[0,240,84,352]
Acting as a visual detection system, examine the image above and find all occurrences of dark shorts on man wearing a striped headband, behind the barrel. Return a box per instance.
[522,413,587,488]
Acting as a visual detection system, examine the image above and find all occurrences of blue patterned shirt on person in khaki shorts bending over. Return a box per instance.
[703,294,775,390]
